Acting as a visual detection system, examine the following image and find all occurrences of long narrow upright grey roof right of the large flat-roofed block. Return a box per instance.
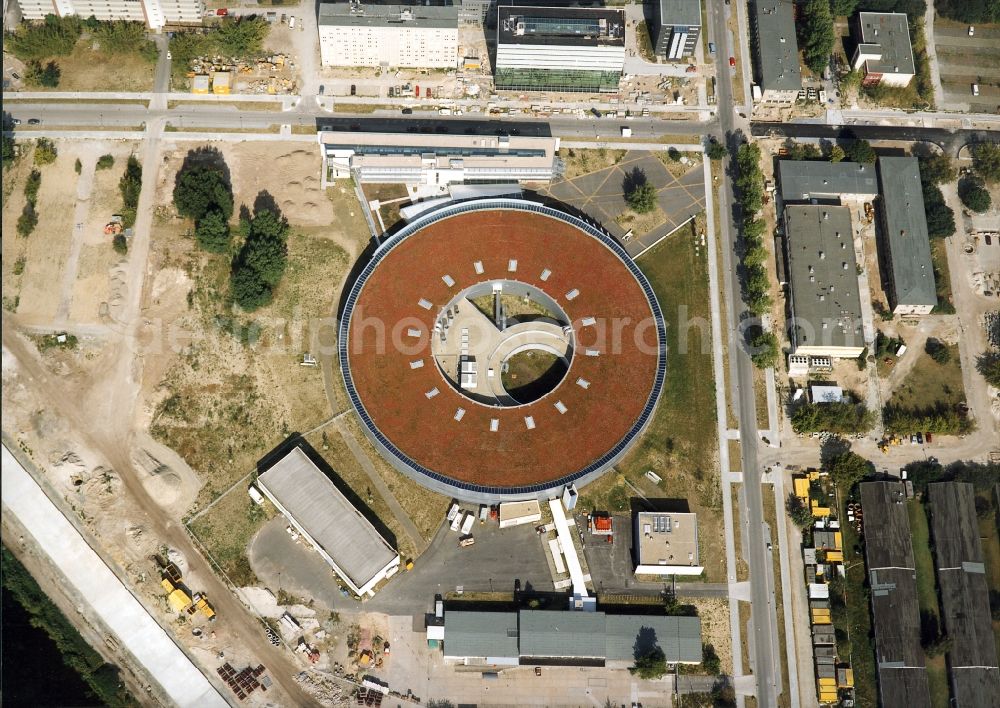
[878,157,937,305]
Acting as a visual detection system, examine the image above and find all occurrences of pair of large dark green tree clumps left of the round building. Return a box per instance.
[174,156,289,310]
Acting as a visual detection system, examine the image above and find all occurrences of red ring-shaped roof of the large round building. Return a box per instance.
[346,209,660,487]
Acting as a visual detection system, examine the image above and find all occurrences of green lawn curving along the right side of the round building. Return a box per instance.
[581,216,726,582]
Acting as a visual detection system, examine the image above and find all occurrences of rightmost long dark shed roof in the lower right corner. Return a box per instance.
[927,482,1000,706]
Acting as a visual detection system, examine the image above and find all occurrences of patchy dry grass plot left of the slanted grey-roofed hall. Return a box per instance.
[188,481,278,587]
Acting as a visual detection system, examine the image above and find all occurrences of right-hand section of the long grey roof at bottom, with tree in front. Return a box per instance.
[605,615,702,662]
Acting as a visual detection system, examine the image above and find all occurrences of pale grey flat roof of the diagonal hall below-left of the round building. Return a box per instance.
[257,447,397,588]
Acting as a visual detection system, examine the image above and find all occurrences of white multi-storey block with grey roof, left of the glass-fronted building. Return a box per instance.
[319,0,459,69]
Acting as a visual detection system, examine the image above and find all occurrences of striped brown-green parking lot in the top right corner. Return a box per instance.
[934,19,1000,113]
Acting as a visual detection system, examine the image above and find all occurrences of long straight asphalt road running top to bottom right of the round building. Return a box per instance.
[712,2,784,706]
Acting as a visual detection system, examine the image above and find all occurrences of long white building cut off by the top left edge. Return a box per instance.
[17,0,205,30]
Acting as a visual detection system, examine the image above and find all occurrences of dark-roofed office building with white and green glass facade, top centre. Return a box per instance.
[494,5,625,93]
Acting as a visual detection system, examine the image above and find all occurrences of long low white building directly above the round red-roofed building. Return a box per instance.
[319,131,559,187]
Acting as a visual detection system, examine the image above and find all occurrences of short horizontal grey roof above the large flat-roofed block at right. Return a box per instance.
[778,160,878,203]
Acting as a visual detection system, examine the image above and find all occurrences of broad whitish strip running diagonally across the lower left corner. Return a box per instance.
[0,446,228,708]
